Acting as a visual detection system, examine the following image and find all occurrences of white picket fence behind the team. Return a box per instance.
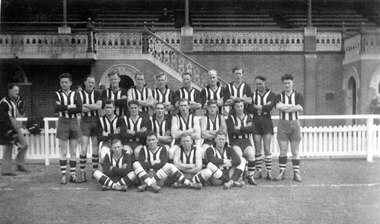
[0,115,380,165]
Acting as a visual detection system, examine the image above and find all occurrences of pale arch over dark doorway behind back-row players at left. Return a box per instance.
[99,64,140,88]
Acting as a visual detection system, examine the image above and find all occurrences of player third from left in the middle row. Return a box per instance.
[151,102,173,151]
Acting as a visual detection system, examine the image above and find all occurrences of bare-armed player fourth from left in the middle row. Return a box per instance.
[169,98,201,162]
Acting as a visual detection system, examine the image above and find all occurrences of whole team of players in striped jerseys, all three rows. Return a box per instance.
[54,68,303,192]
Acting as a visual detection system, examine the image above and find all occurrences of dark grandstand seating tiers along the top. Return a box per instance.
[1,0,379,32]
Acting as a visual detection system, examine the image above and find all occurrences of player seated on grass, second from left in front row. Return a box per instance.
[133,131,200,193]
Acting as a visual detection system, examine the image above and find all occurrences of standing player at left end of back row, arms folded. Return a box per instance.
[54,73,82,184]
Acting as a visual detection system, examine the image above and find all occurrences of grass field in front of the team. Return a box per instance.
[0,159,380,223]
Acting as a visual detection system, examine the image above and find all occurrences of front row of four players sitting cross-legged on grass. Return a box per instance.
[94,131,246,193]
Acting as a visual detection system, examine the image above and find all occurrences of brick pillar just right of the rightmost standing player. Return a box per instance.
[304,27,318,115]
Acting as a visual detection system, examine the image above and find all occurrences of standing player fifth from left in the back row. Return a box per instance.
[152,72,175,114]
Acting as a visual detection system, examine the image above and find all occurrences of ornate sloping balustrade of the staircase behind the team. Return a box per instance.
[146,27,227,87]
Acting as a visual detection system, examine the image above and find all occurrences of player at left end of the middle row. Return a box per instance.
[97,99,124,164]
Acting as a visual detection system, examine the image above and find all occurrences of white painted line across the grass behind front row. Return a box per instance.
[0,183,380,191]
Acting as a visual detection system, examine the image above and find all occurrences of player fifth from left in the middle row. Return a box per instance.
[201,100,227,159]
